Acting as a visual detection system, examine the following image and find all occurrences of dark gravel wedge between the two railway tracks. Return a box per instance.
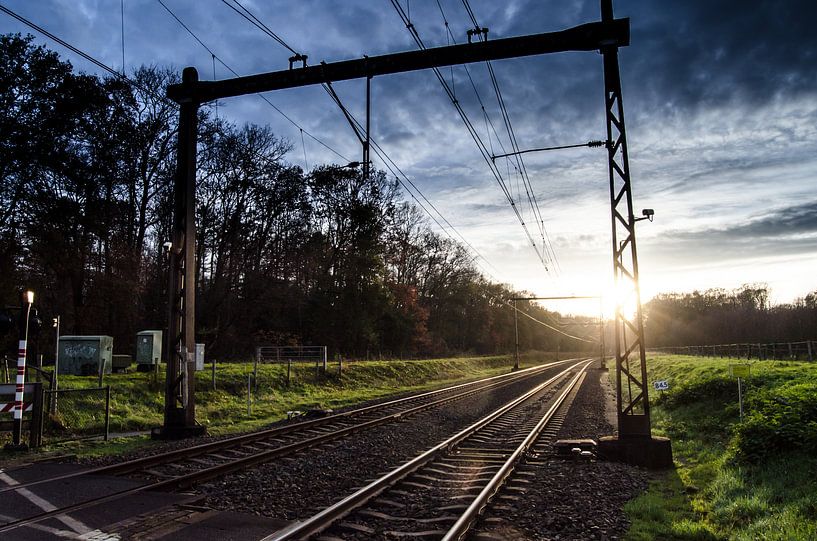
[198,369,572,520]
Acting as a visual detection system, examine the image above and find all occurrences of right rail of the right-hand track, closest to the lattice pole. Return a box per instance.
[442,363,590,541]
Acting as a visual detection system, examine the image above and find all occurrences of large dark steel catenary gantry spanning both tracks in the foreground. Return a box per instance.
[157,0,668,464]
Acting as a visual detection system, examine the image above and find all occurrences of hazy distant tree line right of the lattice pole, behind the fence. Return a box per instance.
[644,284,817,347]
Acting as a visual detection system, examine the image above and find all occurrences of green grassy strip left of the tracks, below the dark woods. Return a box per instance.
[12,353,560,453]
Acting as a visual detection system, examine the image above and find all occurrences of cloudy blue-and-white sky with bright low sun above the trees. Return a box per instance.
[0,0,817,312]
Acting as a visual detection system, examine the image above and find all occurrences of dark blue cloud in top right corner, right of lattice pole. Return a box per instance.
[617,0,817,109]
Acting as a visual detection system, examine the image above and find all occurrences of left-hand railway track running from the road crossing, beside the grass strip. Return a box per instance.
[0,361,570,537]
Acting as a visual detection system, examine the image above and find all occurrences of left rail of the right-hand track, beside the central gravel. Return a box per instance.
[262,361,591,541]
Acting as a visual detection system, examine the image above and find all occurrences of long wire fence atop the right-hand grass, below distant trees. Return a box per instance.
[650,340,817,361]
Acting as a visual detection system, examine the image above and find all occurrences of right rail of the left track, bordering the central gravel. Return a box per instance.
[0,360,575,533]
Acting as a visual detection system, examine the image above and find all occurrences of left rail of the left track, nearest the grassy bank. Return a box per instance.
[0,359,571,494]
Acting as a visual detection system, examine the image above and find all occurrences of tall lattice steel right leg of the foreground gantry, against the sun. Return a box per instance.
[601,0,650,438]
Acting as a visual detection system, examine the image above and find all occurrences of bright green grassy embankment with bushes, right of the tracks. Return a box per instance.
[626,355,817,541]
